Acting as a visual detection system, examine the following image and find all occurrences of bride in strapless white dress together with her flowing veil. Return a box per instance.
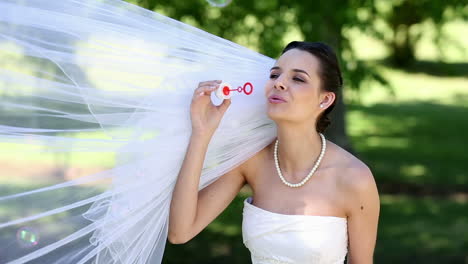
[0,0,379,264]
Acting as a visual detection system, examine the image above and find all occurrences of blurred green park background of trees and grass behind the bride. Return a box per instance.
[0,0,468,264]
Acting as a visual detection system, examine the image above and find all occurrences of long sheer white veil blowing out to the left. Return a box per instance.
[0,0,276,264]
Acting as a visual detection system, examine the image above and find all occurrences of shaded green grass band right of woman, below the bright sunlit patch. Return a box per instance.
[348,102,468,187]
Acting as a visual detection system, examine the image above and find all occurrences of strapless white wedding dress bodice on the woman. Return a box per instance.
[242,197,348,264]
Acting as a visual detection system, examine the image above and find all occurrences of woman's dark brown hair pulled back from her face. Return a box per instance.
[281,41,343,132]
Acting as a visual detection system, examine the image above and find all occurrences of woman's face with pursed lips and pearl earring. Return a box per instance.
[265,49,334,125]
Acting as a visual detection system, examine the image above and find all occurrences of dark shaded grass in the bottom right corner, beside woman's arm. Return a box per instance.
[375,195,468,264]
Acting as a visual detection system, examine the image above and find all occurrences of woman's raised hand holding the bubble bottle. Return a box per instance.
[190,80,231,137]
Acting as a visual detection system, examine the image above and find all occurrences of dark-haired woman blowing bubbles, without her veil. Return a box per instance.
[169,42,379,263]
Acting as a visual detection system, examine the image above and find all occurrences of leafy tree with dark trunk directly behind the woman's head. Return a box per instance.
[133,0,384,150]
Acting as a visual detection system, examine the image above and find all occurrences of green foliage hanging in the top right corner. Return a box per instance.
[366,0,468,67]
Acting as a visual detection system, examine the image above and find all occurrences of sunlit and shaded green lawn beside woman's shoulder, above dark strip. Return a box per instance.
[347,63,468,190]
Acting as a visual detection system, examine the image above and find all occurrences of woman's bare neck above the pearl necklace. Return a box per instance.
[277,121,322,179]
